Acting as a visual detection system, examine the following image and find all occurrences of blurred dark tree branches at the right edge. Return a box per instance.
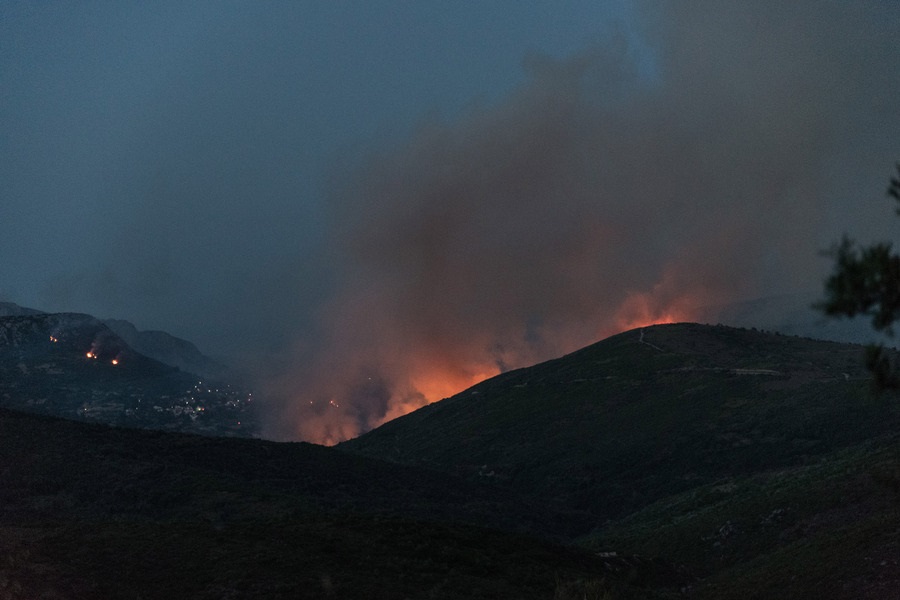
[816,163,900,389]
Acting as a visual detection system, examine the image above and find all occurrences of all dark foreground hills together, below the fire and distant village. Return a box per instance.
[0,324,900,600]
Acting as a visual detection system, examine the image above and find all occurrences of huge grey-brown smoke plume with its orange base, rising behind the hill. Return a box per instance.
[270,2,900,443]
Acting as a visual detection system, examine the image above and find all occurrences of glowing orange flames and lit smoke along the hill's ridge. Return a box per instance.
[294,254,733,445]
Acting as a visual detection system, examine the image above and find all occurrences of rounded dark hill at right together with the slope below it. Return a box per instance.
[339,324,900,598]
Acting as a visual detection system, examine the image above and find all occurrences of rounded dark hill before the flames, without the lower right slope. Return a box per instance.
[340,324,884,522]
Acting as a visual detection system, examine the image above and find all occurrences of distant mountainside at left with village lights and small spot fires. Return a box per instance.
[0,304,258,435]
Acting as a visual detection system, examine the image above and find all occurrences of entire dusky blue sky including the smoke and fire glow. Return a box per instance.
[0,0,900,443]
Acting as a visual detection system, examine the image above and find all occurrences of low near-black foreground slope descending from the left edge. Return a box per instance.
[0,409,632,600]
